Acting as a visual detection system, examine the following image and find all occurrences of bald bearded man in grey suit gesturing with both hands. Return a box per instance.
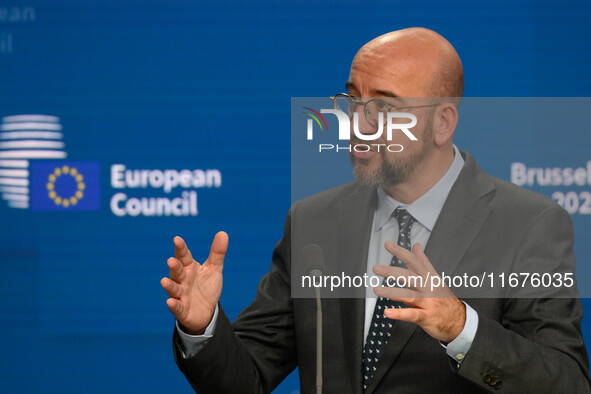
[161,28,590,393]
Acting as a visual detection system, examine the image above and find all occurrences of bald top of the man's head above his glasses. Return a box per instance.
[351,27,464,97]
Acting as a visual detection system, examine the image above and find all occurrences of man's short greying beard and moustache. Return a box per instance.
[349,119,433,188]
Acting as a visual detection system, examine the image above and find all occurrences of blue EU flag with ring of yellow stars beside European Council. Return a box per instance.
[30,160,100,211]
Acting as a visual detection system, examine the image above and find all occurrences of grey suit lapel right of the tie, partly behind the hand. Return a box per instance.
[366,152,494,393]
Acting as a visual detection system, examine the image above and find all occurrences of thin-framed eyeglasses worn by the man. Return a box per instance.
[330,93,439,128]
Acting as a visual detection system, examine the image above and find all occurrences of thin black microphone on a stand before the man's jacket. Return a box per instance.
[304,244,325,394]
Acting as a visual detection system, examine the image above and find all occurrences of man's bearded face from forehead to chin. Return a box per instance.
[347,45,434,187]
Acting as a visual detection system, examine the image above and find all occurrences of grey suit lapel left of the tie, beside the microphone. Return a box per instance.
[337,188,377,393]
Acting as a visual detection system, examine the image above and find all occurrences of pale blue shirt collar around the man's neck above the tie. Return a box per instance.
[375,145,464,231]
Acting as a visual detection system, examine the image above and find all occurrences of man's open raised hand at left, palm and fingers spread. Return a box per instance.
[160,231,228,335]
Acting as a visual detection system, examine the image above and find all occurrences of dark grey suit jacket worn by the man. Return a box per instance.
[173,152,591,393]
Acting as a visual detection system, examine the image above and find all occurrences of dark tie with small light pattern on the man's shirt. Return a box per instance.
[363,208,415,390]
